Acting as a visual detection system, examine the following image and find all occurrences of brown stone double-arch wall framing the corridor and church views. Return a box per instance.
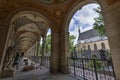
[0,0,120,80]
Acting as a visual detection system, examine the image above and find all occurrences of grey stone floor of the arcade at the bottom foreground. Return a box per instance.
[0,69,76,80]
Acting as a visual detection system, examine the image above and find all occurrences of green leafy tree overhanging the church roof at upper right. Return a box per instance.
[94,7,106,36]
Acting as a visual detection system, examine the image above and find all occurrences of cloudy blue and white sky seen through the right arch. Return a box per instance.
[69,4,99,44]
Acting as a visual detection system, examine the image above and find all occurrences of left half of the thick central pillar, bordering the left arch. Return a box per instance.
[50,32,59,73]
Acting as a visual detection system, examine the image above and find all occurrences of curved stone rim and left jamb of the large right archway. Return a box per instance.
[60,0,100,73]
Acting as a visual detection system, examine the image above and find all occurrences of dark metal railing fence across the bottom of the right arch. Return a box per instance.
[68,58,116,80]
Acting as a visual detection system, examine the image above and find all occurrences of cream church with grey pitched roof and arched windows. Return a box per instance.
[76,29,110,59]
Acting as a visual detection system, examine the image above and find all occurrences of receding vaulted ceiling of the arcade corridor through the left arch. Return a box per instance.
[13,14,48,51]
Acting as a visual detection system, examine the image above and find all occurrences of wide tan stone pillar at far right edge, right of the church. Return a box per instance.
[103,2,120,80]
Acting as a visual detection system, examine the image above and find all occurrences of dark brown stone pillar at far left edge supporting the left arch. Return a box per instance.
[0,22,12,76]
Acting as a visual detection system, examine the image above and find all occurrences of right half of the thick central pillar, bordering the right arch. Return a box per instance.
[60,32,69,73]
